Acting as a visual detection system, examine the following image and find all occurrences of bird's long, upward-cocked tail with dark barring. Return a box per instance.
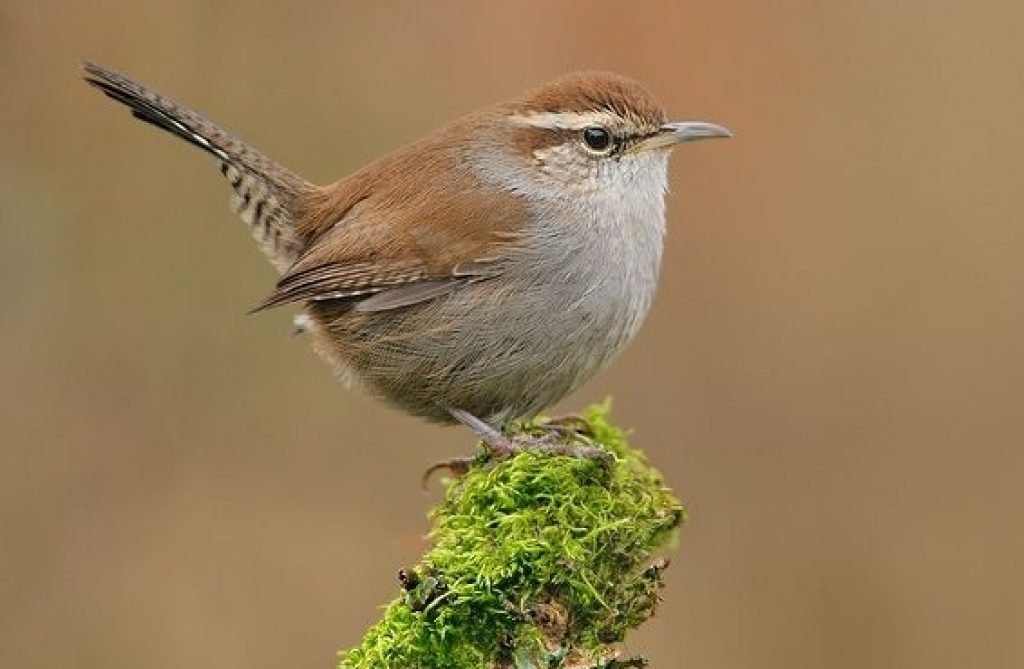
[82,62,313,271]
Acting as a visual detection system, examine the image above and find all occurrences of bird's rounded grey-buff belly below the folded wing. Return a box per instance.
[310,266,649,423]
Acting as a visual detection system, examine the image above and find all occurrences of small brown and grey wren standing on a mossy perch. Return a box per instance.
[84,64,730,452]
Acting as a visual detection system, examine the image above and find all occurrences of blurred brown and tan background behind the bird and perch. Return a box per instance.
[0,0,1024,669]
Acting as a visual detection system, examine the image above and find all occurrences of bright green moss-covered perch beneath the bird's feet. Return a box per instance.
[340,407,685,669]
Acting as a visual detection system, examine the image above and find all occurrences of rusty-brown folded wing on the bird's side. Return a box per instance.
[255,126,525,311]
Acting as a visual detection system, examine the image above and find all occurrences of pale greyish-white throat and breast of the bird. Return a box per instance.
[501,149,668,385]
